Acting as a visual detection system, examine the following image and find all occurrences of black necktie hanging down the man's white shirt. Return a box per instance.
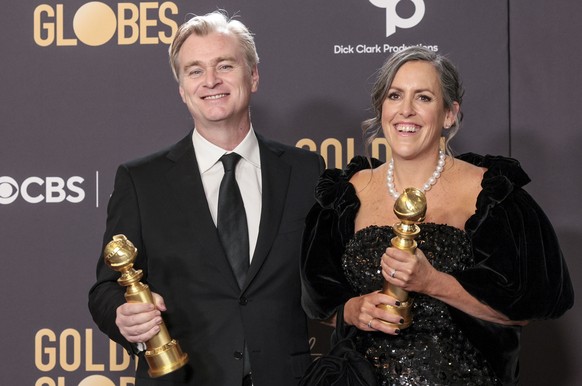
[217,153,249,288]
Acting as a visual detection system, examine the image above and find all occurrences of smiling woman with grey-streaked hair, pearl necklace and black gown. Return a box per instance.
[302,47,573,385]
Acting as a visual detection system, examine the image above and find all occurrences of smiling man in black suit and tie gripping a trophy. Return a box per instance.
[89,12,324,386]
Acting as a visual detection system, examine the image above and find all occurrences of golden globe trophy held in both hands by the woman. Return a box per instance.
[378,188,426,329]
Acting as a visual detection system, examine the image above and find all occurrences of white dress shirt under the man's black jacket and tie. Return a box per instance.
[192,127,263,264]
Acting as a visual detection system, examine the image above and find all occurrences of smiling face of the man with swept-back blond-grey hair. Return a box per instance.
[178,32,259,130]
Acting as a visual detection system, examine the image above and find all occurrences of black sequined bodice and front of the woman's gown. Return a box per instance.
[342,223,499,386]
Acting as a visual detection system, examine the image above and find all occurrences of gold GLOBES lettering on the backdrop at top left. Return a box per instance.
[34,1,178,47]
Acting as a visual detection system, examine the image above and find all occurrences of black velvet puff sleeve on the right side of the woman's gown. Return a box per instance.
[454,154,574,320]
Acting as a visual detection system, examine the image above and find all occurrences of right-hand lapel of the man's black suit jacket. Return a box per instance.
[244,135,291,288]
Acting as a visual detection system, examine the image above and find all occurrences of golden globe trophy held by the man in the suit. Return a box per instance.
[103,235,188,378]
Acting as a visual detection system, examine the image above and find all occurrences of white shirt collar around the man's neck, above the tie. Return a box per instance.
[192,126,261,173]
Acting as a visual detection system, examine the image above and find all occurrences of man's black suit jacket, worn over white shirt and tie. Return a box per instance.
[89,134,323,386]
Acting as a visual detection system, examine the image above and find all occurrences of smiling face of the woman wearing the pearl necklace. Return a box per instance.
[382,61,459,159]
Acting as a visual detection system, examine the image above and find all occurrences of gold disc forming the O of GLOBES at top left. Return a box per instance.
[73,1,117,46]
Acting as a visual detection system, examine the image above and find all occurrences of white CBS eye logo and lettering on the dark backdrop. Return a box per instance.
[0,176,85,205]
